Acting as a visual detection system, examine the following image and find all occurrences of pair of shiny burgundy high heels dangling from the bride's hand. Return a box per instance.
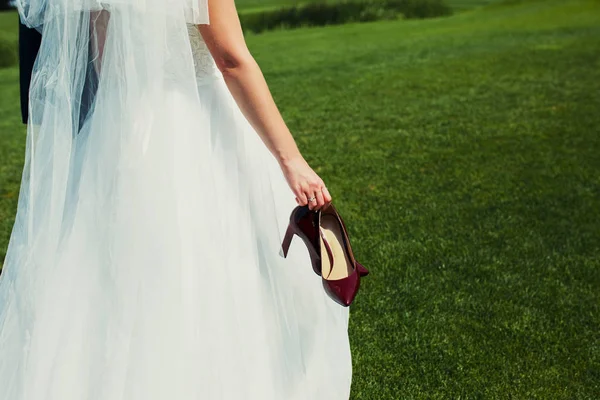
[281,204,369,307]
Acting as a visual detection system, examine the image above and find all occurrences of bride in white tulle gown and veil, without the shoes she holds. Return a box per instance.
[0,0,352,400]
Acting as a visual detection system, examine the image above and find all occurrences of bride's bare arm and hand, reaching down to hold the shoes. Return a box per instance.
[199,0,331,209]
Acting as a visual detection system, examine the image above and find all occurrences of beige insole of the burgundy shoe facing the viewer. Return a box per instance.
[321,215,353,280]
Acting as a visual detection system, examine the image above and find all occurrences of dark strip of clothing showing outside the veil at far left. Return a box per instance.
[19,21,42,124]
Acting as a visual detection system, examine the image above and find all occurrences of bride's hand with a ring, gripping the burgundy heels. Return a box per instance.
[280,156,331,210]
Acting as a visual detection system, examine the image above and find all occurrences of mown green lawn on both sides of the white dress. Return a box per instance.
[0,0,600,400]
